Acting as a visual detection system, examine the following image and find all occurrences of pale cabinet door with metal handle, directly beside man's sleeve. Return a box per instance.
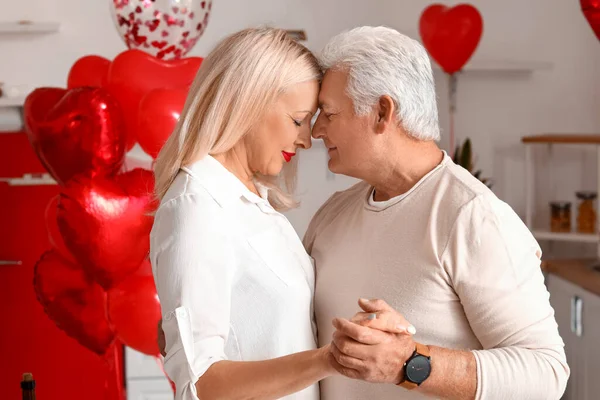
[546,274,582,400]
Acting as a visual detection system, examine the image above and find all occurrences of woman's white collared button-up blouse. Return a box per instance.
[150,156,319,400]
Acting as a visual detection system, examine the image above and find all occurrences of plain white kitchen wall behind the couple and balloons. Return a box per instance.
[0,0,600,242]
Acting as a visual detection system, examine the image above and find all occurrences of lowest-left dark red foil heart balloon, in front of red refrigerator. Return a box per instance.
[33,250,115,355]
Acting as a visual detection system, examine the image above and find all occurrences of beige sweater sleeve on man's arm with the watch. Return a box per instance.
[442,194,569,400]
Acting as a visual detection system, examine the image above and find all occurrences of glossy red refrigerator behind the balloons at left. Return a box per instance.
[0,132,123,400]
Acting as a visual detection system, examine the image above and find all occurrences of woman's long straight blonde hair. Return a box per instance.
[154,28,321,210]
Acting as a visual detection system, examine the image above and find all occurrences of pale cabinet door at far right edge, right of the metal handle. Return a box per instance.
[579,284,600,400]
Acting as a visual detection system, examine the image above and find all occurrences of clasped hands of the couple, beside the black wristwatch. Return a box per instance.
[331,299,415,384]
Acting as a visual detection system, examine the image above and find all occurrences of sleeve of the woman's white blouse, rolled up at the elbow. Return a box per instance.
[150,195,235,400]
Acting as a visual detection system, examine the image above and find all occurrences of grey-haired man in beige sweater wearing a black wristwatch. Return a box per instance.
[305,27,569,400]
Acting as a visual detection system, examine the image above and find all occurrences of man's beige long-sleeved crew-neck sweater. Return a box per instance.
[305,155,569,400]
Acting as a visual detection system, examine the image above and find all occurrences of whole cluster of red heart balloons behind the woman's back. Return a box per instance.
[24,50,202,355]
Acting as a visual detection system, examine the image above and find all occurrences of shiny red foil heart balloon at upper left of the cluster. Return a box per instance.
[24,87,125,185]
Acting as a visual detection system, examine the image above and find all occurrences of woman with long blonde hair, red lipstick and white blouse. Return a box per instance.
[150,29,336,400]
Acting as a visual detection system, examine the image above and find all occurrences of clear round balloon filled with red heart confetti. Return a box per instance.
[110,0,212,60]
